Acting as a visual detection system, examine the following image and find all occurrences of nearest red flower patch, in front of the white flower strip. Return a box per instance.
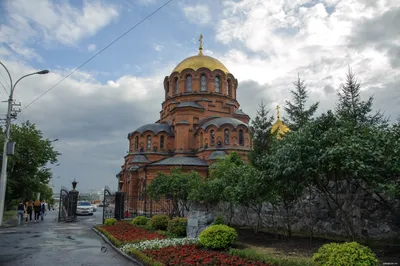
[142,245,271,266]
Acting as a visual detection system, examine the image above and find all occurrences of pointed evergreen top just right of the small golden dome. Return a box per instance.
[284,74,319,131]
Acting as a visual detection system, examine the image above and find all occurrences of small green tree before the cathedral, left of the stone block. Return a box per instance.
[147,168,202,217]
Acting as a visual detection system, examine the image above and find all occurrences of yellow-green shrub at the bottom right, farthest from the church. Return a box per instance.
[312,242,378,266]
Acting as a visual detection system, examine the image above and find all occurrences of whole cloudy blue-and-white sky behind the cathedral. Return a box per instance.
[0,0,400,192]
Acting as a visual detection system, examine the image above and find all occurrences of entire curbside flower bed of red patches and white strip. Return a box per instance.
[97,222,271,266]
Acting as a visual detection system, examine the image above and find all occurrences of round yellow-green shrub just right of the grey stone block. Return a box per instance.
[200,224,237,249]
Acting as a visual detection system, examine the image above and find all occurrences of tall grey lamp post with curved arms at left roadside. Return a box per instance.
[0,62,49,225]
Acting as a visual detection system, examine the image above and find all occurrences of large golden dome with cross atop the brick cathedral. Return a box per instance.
[172,35,229,74]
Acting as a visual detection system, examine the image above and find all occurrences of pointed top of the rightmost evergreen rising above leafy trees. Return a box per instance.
[336,67,383,125]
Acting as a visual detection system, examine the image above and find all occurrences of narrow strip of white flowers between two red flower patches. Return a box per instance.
[121,238,199,253]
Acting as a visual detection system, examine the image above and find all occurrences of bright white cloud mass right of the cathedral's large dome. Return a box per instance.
[215,0,400,116]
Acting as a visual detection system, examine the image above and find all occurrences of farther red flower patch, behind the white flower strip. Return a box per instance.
[97,222,166,246]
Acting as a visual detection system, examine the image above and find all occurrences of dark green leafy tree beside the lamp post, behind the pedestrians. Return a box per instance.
[1,121,60,208]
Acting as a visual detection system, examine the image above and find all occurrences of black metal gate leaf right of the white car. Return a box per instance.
[103,186,125,224]
